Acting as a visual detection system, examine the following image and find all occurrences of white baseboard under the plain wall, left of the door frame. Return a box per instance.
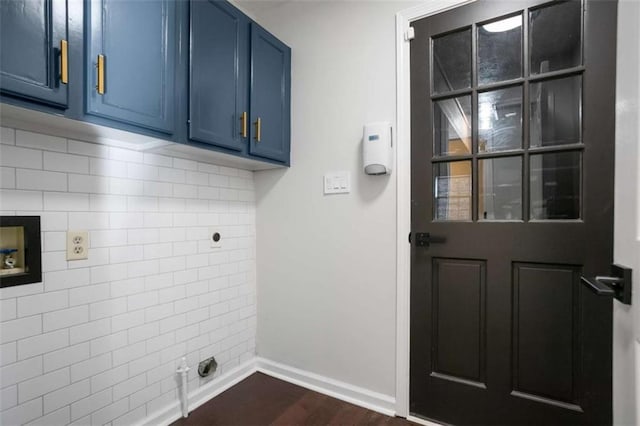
[256,357,396,416]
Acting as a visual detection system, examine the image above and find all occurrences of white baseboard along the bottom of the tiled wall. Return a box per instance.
[140,358,256,426]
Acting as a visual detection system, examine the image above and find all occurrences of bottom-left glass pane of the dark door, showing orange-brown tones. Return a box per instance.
[433,161,471,220]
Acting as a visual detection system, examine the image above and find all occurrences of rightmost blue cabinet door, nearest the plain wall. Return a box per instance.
[249,23,291,164]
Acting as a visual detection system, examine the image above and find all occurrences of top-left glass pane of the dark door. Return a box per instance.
[432,29,471,93]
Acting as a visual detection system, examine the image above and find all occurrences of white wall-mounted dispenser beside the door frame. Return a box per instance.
[362,121,393,175]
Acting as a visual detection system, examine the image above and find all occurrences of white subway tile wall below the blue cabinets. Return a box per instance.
[0,128,256,426]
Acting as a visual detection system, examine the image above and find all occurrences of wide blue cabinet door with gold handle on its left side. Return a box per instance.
[85,0,176,133]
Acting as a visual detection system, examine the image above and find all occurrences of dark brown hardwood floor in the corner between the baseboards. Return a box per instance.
[173,373,415,426]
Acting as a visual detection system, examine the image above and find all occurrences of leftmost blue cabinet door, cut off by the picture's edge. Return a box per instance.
[0,0,68,107]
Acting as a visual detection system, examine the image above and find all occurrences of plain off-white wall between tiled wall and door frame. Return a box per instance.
[256,1,416,397]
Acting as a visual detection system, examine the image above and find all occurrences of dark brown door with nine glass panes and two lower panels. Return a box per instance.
[410,0,617,425]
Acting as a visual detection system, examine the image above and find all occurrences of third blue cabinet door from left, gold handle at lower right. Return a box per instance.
[189,0,249,151]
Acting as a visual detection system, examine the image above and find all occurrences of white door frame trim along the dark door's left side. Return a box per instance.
[396,0,475,420]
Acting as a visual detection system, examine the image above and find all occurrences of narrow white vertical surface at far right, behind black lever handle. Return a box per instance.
[613,0,640,426]
